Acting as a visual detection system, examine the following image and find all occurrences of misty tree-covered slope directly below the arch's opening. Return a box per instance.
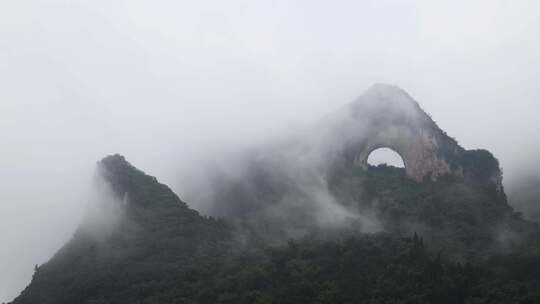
[330,165,540,261]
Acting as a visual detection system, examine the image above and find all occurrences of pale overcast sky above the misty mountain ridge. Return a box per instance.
[0,0,540,302]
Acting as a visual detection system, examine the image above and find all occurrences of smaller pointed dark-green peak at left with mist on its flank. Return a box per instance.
[13,155,231,304]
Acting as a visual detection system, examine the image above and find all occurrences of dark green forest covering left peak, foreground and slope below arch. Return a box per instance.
[13,156,540,304]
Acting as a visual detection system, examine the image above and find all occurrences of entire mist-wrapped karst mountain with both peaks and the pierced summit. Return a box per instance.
[12,84,540,304]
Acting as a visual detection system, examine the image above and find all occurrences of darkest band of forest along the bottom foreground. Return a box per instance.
[14,235,540,304]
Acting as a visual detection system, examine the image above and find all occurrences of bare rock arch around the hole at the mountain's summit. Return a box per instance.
[346,84,502,189]
